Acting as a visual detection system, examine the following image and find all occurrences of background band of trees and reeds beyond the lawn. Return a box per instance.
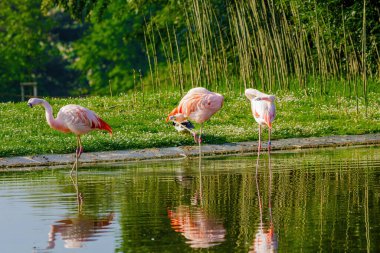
[0,0,380,100]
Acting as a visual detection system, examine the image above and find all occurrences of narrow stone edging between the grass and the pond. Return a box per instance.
[0,133,380,172]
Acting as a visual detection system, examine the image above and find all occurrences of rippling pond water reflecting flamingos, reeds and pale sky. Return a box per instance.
[0,147,380,253]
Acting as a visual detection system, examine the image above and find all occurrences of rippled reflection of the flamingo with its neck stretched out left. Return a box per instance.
[47,175,114,249]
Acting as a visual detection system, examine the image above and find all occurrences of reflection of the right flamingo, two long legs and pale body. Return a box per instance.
[250,152,278,252]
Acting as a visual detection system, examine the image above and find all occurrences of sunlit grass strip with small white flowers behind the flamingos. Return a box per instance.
[0,92,380,156]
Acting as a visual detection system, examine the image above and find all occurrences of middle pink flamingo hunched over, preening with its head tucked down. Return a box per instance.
[166,87,224,148]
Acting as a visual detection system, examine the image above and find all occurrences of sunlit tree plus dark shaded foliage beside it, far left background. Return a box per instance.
[0,0,86,100]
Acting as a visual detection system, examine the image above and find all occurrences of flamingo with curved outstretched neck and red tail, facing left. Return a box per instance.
[28,98,112,173]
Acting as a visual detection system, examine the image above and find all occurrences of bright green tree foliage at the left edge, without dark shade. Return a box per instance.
[0,0,51,100]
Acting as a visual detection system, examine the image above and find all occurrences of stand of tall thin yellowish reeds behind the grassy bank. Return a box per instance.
[139,0,380,112]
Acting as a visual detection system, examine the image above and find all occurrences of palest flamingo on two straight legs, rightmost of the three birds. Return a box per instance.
[245,89,276,153]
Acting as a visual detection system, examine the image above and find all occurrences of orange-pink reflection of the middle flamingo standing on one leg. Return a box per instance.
[168,155,226,248]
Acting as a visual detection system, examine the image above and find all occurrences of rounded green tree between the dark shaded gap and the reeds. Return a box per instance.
[70,1,186,94]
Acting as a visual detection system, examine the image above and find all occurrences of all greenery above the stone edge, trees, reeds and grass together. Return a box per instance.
[0,0,380,156]
